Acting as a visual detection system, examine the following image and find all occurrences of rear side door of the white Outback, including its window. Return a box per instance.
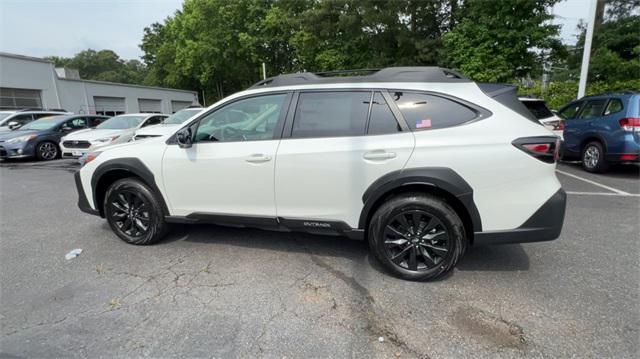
[275,90,414,228]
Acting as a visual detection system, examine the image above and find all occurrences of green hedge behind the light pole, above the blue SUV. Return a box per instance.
[518,79,640,110]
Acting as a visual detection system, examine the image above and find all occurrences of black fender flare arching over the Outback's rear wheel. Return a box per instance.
[358,167,482,232]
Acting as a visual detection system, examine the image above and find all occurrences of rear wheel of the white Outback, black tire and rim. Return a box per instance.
[368,193,467,281]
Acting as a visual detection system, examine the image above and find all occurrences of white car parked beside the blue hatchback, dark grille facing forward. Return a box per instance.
[60,113,168,158]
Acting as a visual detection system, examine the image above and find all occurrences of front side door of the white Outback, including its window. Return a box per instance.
[162,92,291,218]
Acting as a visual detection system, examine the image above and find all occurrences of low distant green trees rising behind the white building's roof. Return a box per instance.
[47,49,146,84]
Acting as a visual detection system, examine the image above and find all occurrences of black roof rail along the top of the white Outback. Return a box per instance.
[250,66,471,89]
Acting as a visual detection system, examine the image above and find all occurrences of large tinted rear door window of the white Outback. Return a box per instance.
[291,91,371,138]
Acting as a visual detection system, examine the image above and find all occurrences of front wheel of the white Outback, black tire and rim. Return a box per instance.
[103,178,168,245]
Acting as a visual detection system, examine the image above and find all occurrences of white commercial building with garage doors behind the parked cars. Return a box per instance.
[0,52,198,116]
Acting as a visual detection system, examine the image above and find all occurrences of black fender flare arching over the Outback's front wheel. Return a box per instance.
[91,157,169,215]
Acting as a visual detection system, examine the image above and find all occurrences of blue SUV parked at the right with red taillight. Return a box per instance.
[558,92,640,172]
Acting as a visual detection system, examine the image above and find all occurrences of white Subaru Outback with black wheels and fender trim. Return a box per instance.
[75,67,566,280]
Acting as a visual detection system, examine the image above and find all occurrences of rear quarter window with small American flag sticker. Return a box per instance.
[391,91,477,130]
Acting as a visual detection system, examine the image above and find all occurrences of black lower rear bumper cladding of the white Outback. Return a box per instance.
[473,188,567,245]
